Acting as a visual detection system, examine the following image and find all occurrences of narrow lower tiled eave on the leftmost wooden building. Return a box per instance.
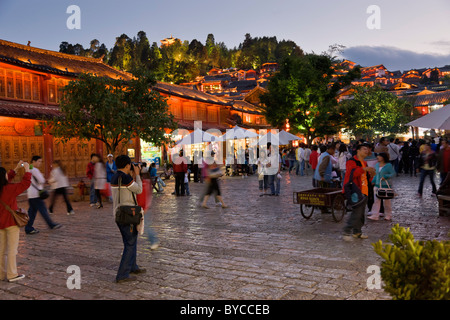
[0,100,61,119]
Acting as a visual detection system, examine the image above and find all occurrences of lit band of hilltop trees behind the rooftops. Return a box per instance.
[60,31,303,84]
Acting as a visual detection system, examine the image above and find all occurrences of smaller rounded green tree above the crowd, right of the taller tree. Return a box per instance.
[340,85,413,139]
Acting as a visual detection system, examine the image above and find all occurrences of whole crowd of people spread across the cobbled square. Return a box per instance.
[0,138,450,282]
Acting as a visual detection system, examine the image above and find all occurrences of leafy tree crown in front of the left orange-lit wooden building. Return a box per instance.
[47,73,176,154]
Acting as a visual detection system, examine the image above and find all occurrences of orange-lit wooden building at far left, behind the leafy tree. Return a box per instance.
[0,40,134,177]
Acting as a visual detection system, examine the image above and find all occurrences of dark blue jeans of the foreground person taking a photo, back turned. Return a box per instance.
[116,223,139,280]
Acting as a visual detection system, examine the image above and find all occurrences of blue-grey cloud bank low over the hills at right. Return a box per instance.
[341,46,450,71]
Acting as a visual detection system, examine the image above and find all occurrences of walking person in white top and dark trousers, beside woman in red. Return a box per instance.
[25,156,61,234]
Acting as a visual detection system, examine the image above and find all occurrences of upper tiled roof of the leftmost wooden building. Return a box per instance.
[0,39,133,80]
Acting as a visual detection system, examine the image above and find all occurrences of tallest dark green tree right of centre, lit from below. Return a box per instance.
[261,54,358,144]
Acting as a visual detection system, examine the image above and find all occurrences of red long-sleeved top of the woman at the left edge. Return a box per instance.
[0,170,31,229]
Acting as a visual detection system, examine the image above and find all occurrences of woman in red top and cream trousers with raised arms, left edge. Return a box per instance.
[0,160,31,282]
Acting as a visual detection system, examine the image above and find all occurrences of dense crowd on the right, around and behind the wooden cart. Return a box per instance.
[281,137,450,240]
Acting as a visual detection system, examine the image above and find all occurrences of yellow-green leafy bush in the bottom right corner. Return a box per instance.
[373,224,450,300]
